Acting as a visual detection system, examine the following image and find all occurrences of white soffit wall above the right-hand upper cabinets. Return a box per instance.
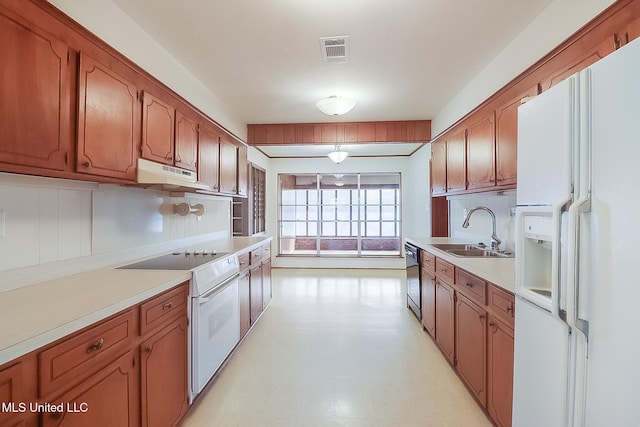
[431,0,614,136]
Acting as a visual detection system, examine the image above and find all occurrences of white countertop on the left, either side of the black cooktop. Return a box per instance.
[0,237,270,365]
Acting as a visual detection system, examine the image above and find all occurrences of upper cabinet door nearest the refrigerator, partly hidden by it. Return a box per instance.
[496,85,538,185]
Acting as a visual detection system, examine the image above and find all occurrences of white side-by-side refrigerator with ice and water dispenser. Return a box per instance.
[513,36,640,427]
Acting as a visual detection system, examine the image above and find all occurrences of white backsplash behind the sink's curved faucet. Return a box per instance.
[449,190,516,252]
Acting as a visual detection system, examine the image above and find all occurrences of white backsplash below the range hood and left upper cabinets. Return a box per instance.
[0,174,231,288]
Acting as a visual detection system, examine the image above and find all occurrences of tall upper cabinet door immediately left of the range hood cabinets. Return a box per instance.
[76,52,140,181]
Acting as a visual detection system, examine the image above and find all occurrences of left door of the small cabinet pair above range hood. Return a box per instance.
[142,92,176,165]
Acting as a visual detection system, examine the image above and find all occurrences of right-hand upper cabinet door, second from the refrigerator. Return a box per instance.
[467,111,496,190]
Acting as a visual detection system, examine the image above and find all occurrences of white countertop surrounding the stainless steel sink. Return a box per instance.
[405,237,516,293]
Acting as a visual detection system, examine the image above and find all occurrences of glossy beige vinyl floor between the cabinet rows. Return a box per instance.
[182,269,492,427]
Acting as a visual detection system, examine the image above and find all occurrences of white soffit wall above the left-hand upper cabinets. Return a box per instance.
[49,0,247,141]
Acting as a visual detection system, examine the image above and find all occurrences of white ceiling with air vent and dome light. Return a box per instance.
[114,0,551,156]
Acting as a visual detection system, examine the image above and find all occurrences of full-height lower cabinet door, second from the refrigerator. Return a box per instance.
[456,294,487,407]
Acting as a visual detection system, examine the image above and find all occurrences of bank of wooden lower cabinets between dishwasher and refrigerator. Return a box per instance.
[421,254,515,427]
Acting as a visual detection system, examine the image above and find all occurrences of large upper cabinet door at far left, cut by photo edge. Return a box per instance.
[0,11,76,171]
